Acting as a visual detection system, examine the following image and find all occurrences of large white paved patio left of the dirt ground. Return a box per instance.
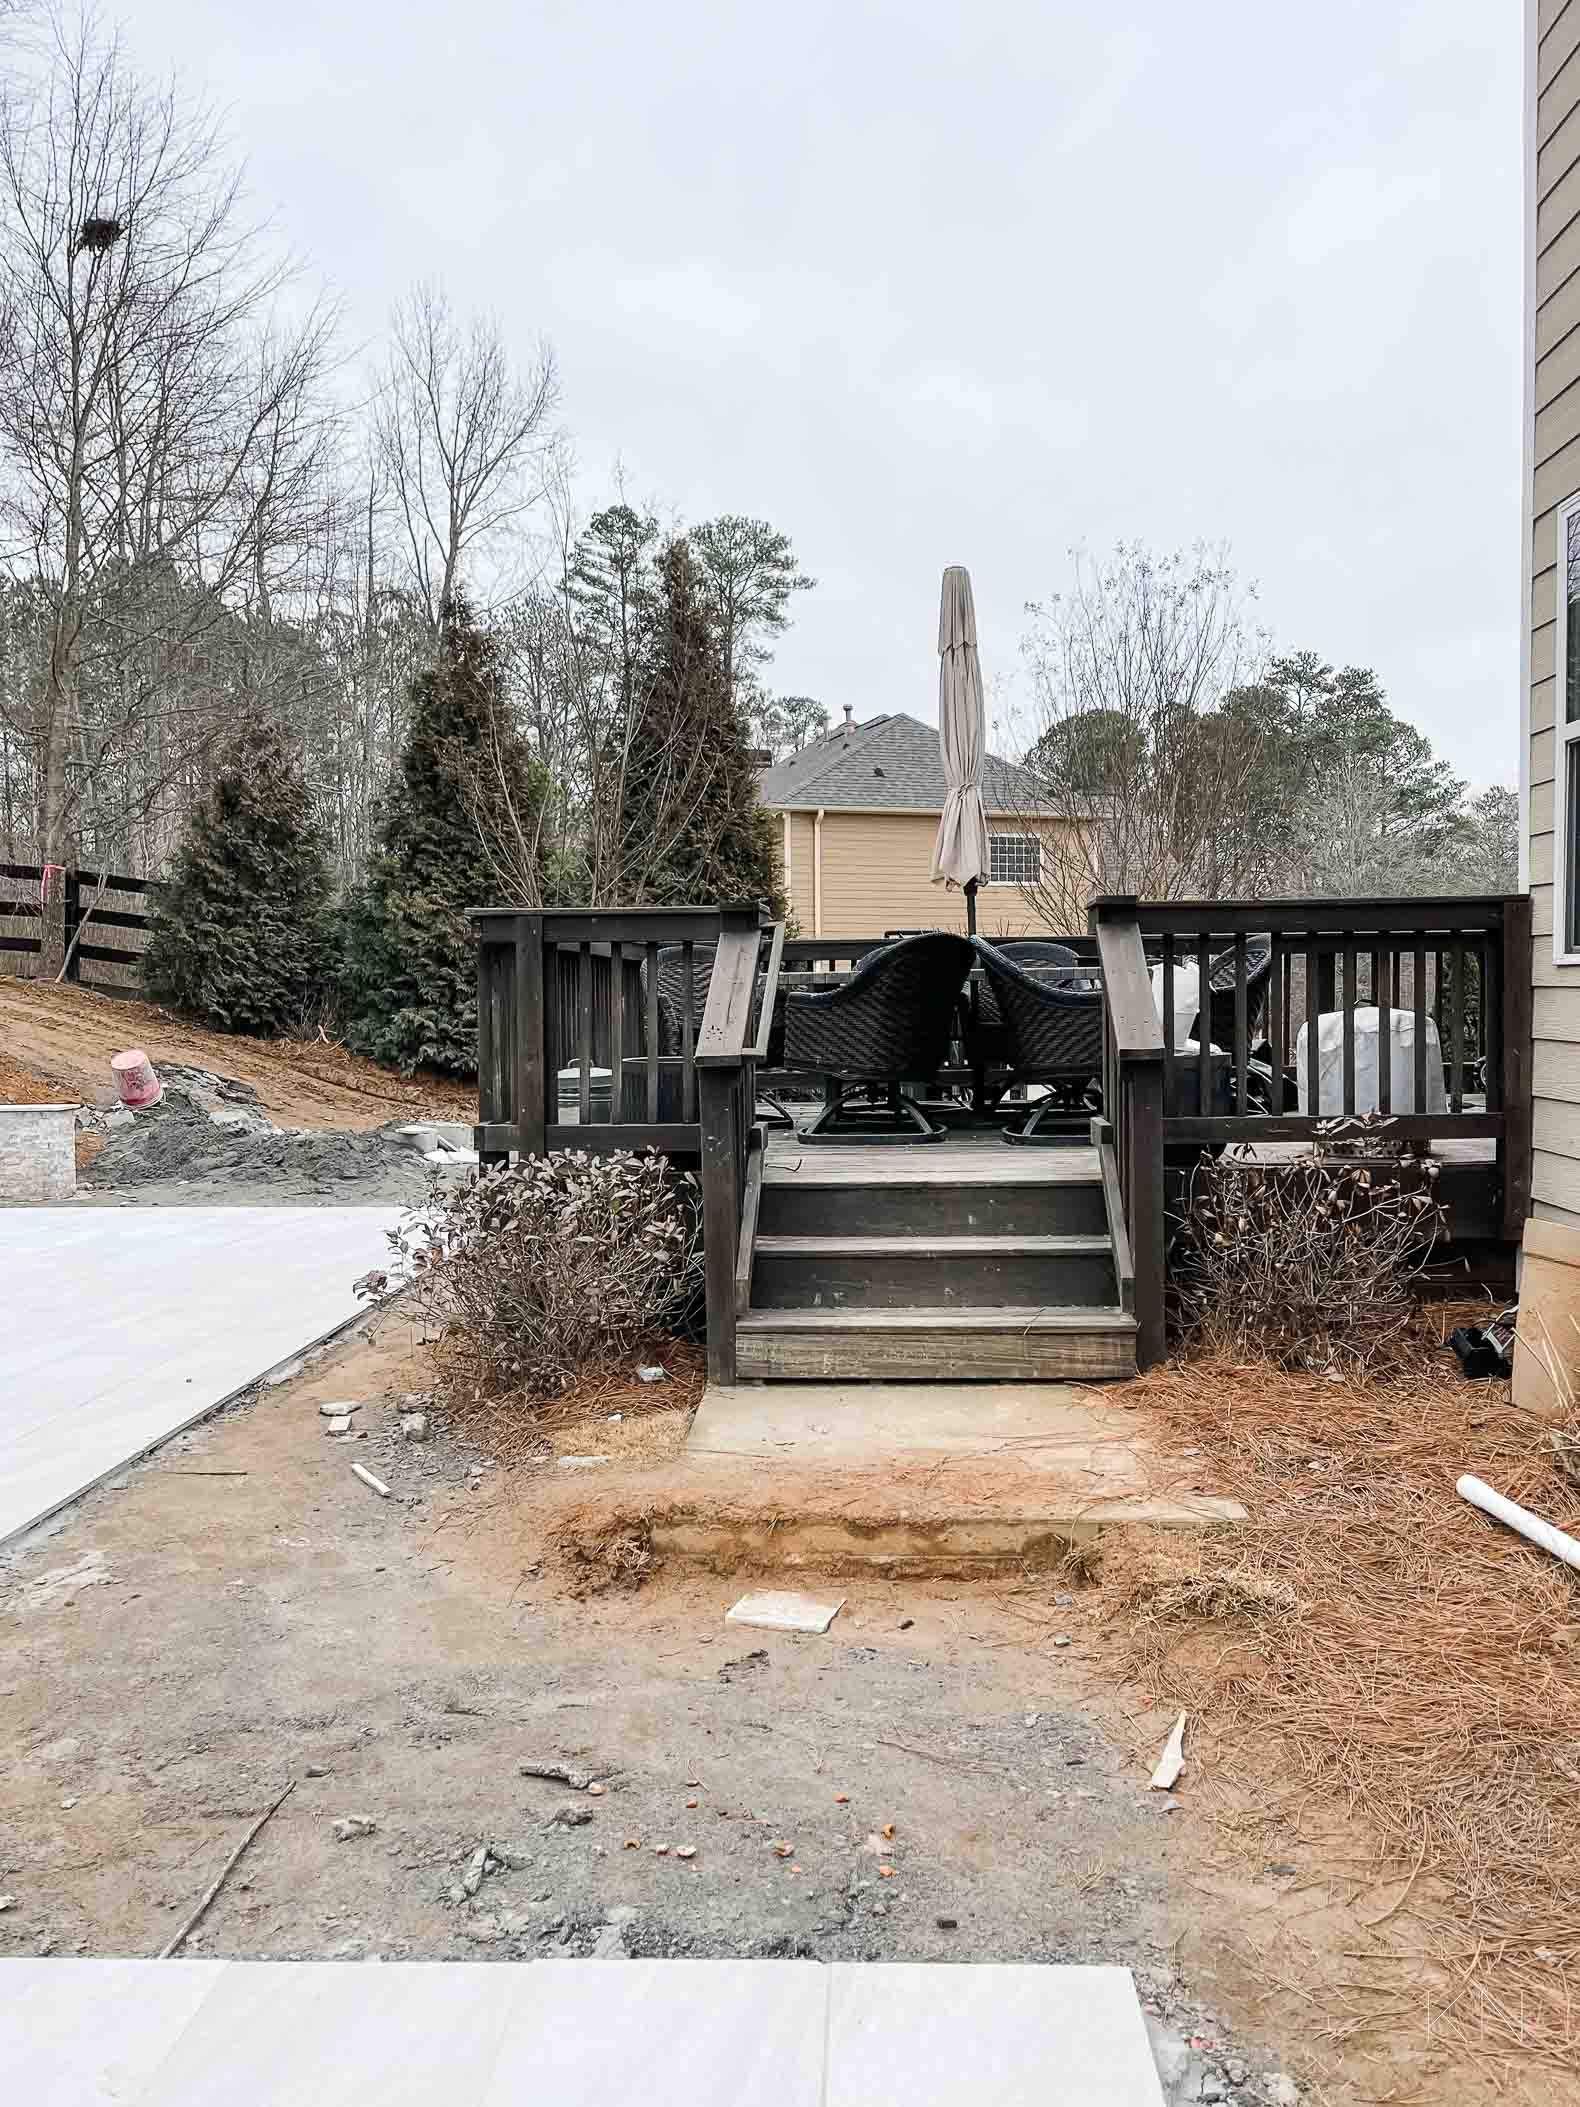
[0,1207,394,1542]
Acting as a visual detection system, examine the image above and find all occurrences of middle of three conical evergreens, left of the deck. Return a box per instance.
[339,603,546,1075]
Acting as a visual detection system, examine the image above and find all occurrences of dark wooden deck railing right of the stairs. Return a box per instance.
[1091,895,1532,1367]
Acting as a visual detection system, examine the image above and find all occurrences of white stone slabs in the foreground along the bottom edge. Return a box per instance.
[0,1960,1163,2107]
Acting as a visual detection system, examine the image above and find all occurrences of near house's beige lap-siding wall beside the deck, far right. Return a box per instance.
[1521,0,1580,1230]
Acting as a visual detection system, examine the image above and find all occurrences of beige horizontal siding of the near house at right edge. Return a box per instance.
[1525,0,1580,1226]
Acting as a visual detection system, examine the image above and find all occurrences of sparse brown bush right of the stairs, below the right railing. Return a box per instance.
[1176,1150,1445,1372]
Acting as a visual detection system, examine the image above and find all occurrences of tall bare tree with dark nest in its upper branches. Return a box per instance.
[0,19,335,963]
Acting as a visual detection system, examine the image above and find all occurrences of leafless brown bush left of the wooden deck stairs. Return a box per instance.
[390,1150,702,1403]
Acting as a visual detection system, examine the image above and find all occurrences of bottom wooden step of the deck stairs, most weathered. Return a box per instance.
[735,1304,1135,1382]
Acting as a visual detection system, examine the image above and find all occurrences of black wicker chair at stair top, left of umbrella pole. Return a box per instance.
[784,936,971,1142]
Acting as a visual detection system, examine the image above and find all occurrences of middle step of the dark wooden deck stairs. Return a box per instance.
[752,1230,1119,1308]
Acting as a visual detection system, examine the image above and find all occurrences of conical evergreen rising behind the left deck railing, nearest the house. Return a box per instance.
[621,539,784,910]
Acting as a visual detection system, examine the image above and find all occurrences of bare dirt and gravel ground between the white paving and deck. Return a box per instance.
[0,1317,1559,2107]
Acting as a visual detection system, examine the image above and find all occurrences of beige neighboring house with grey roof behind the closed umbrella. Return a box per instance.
[758,710,1087,938]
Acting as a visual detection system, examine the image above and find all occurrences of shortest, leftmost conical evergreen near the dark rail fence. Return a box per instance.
[143,723,329,1037]
